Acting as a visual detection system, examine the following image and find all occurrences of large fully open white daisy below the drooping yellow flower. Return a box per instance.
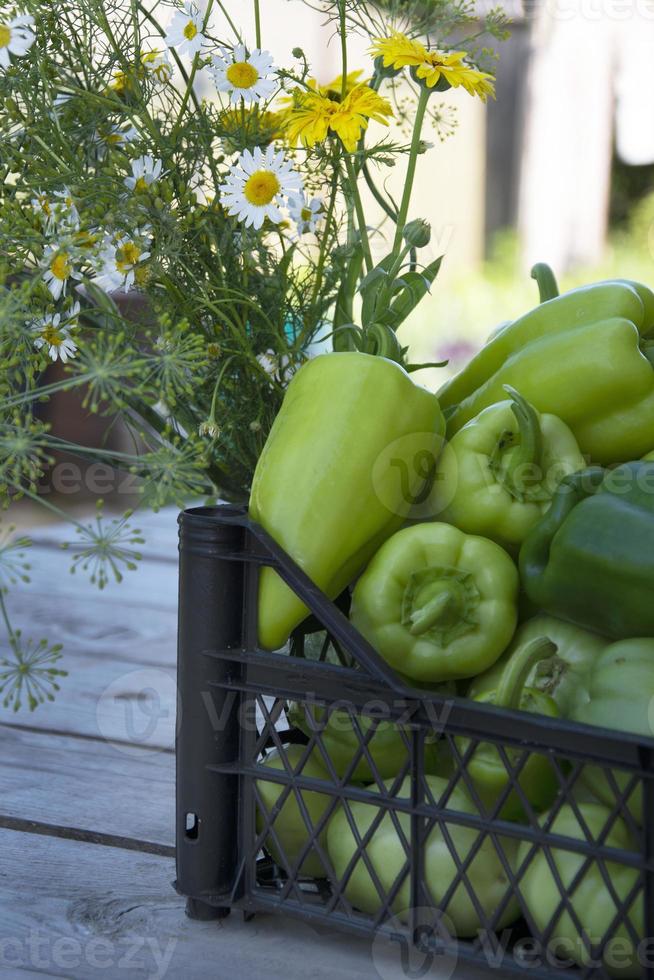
[221,146,302,230]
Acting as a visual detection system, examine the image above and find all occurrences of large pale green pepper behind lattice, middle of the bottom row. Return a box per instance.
[327,776,519,937]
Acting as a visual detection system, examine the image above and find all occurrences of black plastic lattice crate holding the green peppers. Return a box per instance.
[176,506,654,980]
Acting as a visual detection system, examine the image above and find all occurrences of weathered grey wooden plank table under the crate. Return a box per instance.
[0,511,482,980]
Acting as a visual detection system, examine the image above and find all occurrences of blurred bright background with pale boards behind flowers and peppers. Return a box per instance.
[12,0,654,523]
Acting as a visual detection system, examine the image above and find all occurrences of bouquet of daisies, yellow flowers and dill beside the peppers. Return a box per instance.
[0,0,505,707]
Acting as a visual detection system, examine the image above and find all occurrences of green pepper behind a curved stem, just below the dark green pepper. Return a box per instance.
[467,615,609,718]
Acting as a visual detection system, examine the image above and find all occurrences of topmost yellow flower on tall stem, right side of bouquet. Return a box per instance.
[371,31,495,102]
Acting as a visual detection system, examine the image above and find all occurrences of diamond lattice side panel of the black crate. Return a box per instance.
[244,695,643,977]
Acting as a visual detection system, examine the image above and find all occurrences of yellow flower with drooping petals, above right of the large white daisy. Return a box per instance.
[285,85,393,153]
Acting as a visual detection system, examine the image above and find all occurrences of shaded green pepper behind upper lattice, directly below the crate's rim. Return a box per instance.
[288,702,436,783]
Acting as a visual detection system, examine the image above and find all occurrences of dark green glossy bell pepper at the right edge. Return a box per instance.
[520,461,654,639]
